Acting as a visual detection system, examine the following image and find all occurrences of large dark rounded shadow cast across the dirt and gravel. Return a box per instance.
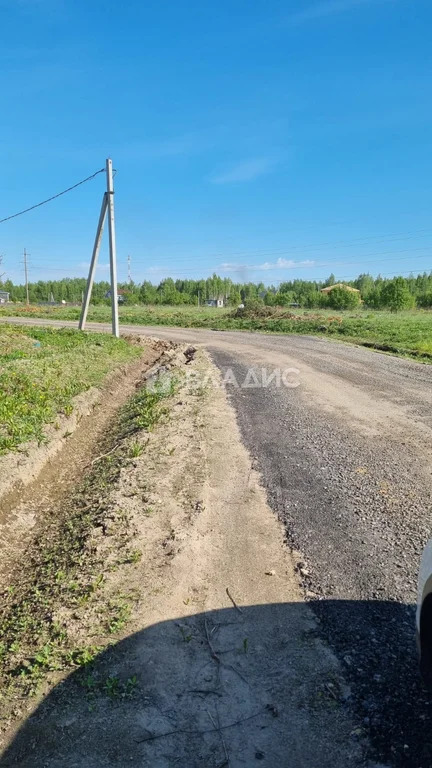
[1,600,432,768]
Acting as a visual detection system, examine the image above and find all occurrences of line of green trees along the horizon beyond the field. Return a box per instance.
[0,271,432,310]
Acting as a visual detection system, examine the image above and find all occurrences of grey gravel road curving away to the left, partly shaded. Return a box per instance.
[2,320,432,768]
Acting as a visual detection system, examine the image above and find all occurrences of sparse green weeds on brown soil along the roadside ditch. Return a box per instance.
[0,376,175,704]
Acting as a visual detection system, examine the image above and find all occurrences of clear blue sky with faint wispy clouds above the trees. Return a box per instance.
[0,0,432,283]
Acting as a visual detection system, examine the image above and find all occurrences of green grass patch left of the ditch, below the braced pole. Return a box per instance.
[0,324,140,454]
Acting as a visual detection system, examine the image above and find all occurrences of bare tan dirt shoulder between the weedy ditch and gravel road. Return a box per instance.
[0,352,370,768]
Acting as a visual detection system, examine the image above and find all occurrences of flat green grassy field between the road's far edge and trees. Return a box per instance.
[0,306,432,362]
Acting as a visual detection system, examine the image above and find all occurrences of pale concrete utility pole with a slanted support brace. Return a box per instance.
[78,158,120,337]
